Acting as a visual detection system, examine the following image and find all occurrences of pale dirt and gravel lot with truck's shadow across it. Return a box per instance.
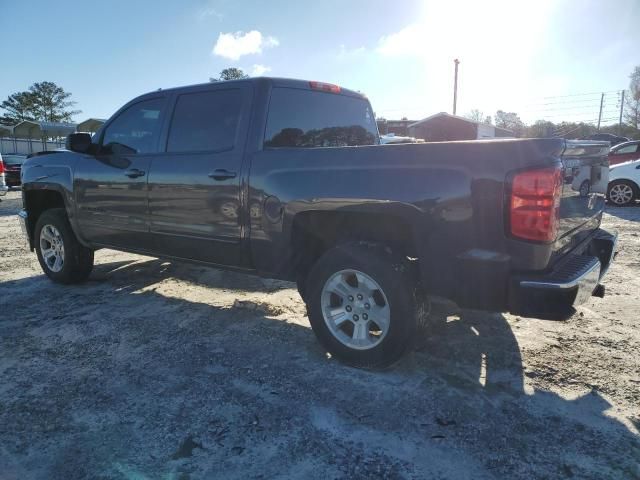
[0,188,640,480]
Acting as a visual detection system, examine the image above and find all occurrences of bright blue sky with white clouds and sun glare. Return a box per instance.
[0,0,640,123]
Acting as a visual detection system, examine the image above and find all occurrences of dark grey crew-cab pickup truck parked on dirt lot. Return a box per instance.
[20,78,616,366]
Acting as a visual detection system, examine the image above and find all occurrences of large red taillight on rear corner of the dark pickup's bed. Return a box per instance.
[509,168,562,242]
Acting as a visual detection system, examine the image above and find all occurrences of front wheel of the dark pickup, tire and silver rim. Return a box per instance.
[34,208,93,283]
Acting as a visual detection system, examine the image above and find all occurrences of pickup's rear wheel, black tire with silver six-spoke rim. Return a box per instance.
[304,243,420,367]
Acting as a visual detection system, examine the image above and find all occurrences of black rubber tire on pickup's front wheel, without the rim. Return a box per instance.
[33,208,93,284]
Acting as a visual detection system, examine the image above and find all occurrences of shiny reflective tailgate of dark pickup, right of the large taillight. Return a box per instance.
[557,140,609,242]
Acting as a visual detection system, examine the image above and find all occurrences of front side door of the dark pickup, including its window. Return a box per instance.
[74,95,167,251]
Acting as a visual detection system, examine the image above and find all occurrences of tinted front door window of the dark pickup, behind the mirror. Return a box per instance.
[102,98,164,155]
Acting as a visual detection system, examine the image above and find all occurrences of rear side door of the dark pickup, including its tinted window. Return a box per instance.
[149,82,252,265]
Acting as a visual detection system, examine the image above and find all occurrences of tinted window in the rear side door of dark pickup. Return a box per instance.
[167,88,242,152]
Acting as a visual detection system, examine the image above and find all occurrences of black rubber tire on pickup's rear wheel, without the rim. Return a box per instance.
[304,243,424,367]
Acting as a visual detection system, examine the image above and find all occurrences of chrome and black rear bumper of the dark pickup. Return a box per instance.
[508,229,617,318]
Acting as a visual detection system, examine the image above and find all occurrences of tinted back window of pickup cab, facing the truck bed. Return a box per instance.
[264,88,378,147]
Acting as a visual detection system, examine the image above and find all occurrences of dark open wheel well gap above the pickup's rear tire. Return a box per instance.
[291,212,418,278]
